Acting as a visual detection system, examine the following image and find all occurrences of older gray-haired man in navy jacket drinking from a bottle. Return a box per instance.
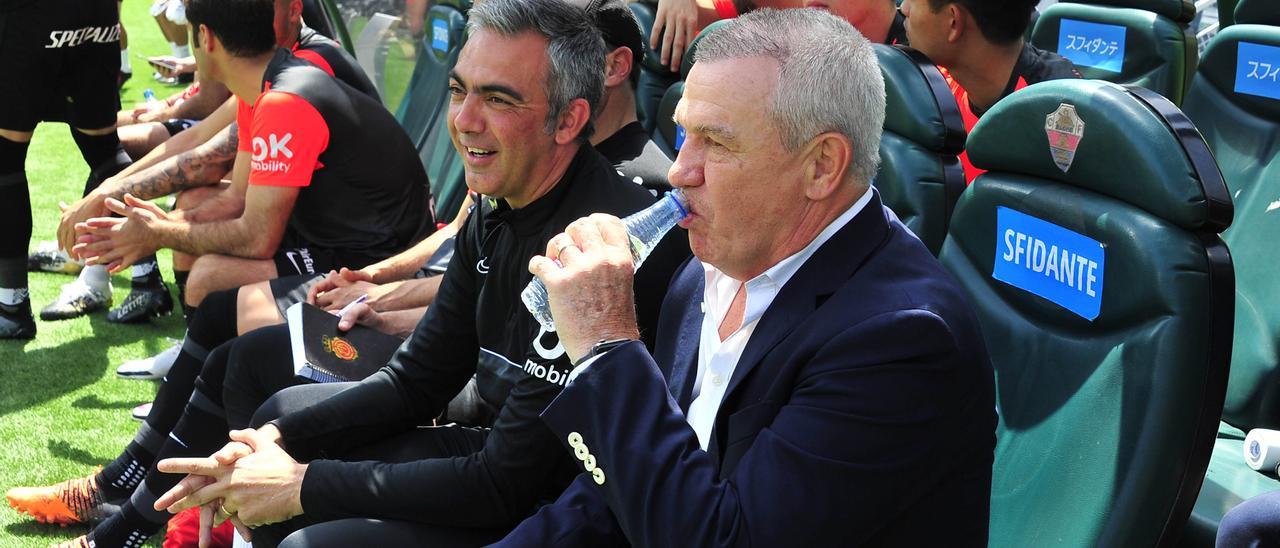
[503,10,996,547]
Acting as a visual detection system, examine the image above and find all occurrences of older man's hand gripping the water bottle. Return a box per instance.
[529,214,640,362]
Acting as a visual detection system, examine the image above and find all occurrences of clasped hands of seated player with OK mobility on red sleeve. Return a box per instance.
[70,195,169,274]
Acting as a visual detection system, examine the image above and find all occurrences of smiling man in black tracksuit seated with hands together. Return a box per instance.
[160,0,687,545]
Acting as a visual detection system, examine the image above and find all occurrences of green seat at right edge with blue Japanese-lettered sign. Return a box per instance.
[1183,17,1280,547]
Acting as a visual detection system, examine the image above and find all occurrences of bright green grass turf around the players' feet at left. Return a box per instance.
[0,1,190,548]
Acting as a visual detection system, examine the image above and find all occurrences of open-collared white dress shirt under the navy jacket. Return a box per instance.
[568,188,872,451]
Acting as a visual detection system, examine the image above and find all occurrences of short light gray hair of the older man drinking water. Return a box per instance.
[694,9,884,184]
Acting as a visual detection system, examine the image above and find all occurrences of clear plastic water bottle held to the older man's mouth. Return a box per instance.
[520,188,689,332]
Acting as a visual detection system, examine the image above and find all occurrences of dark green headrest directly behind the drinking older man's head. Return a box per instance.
[873,44,965,154]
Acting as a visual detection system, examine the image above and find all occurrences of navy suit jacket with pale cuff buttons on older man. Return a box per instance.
[500,196,996,547]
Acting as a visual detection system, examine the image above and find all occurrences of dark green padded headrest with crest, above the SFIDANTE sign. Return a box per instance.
[966,79,1231,232]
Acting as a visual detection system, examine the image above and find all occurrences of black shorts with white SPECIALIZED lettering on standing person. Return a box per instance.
[0,0,120,132]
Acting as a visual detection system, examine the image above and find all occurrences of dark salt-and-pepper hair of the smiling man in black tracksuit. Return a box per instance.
[467,0,605,142]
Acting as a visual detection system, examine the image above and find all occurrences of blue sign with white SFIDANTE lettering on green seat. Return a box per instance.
[991,206,1106,320]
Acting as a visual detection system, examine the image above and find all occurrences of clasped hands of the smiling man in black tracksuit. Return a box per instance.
[155,425,307,547]
